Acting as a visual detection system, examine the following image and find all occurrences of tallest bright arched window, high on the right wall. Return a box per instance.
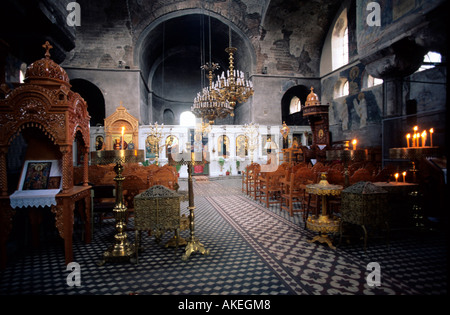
[331,10,348,70]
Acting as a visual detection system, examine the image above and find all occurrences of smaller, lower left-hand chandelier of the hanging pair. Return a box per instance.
[191,62,233,125]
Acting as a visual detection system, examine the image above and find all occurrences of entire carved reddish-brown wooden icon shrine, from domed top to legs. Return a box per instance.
[0,42,90,270]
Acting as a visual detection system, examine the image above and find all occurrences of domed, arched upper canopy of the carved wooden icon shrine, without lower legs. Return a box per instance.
[0,42,90,196]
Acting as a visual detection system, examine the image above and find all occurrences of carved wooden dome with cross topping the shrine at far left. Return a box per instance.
[25,41,69,85]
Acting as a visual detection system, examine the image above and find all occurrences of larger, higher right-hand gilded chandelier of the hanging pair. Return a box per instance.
[212,45,254,116]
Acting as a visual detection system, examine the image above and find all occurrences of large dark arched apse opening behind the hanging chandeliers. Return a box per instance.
[134,8,256,124]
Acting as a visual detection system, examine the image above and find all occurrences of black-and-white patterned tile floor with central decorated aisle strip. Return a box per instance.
[0,179,447,296]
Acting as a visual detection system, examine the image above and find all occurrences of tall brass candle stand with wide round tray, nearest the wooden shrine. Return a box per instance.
[91,150,144,266]
